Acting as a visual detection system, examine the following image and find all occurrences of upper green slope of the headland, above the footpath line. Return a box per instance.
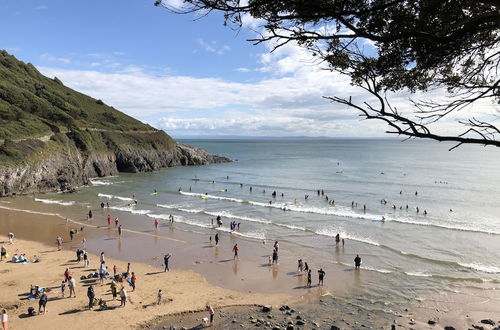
[0,51,154,140]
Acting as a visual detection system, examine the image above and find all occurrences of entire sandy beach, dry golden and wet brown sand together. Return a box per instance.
[0,208,500,329]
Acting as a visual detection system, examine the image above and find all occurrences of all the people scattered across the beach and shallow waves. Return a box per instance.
[0,177,438,329]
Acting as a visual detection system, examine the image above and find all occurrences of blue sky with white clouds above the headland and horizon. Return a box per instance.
[0,0,492,138]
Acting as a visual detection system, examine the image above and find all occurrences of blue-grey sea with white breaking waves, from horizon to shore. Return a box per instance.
[1,139,500,316]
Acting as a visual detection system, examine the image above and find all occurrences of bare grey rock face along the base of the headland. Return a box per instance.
[0,144,230,197]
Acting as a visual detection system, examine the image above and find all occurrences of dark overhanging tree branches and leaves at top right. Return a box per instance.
[155,0,500,146]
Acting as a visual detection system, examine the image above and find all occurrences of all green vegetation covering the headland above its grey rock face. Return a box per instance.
[0,51,175,165]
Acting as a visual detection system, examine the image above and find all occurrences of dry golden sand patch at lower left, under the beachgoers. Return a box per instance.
[0,229,289,329]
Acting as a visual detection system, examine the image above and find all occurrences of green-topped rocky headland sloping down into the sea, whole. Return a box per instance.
[0,51,230,197]
